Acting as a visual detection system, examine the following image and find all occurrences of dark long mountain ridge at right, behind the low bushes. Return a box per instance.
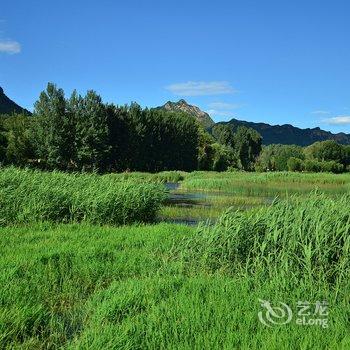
[219,119,350,146]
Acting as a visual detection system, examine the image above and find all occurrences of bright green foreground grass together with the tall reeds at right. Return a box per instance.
[0,193,350,349]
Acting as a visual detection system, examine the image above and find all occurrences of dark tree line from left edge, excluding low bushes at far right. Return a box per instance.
[0,83,261,172]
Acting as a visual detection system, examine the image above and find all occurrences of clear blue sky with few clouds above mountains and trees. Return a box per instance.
[0,0,350,132]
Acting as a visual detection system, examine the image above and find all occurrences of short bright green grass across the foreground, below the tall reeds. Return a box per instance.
[0,223,350,350]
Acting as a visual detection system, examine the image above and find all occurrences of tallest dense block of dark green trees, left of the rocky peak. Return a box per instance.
[29,84,200,172]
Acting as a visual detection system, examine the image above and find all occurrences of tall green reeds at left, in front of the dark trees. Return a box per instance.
[0,168,165,225]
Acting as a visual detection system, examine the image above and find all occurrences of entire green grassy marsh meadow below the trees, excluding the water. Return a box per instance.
[0,168,350,350]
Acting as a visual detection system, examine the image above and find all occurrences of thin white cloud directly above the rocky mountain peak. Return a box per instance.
[166,81,236,96]
